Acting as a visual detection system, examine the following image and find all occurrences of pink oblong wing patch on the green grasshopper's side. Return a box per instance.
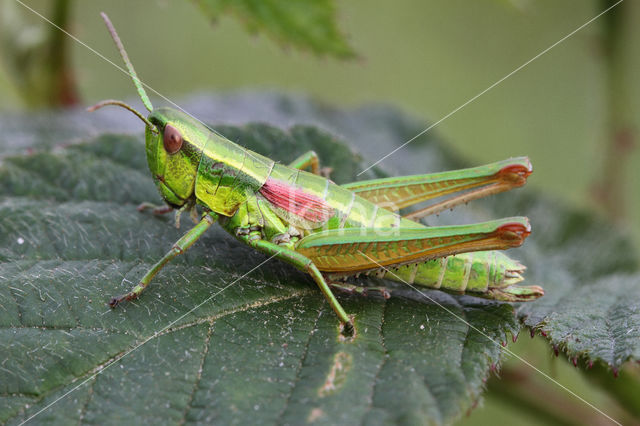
[260,178,333,222]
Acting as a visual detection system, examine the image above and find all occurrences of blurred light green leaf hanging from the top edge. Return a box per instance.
[194,0,355,59]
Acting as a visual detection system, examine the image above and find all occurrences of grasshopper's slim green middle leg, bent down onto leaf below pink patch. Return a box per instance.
[240,234,354,335]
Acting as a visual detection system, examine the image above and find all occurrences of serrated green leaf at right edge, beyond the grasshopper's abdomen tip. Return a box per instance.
[518,198,640,371]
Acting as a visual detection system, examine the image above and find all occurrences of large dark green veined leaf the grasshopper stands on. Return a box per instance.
[0,124,518,423]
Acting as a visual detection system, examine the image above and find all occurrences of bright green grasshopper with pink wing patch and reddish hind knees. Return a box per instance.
[89,13,544,334]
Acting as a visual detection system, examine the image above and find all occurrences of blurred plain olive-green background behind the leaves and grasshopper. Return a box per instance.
[0,0,640,424]
